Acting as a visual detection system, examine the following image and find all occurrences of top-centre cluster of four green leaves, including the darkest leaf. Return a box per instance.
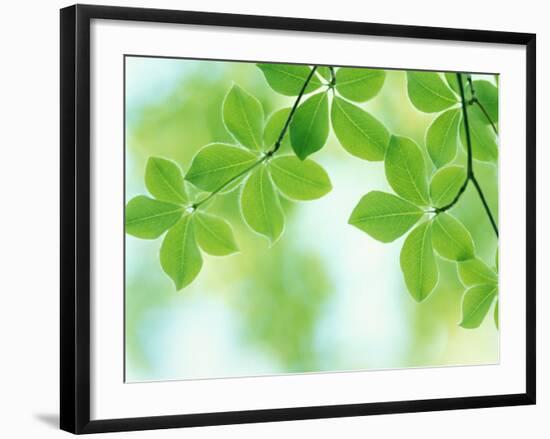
[258,64,390,161]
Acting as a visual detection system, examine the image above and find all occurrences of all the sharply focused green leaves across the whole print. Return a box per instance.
[126,64,498,328]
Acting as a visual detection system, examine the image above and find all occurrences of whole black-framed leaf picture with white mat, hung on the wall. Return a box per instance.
[61,5,536,433]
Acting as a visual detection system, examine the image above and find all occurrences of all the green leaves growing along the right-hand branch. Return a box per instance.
[349,72,498,328]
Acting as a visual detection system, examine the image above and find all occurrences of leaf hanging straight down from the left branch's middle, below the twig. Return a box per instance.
[241,166,285,245]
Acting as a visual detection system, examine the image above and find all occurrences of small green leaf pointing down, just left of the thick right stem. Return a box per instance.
[426,108,461,168]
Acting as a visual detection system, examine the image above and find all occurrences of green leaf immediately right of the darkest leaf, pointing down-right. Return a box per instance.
[331,96,390,161]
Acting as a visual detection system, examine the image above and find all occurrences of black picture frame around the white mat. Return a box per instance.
[60,5,536,434]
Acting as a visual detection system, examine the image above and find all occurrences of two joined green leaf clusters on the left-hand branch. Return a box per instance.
[126,81,332,289]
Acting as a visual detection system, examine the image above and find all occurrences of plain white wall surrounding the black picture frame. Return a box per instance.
[0,0,550,439]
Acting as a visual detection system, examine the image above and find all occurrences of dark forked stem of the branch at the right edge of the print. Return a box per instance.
[435,73,498,238]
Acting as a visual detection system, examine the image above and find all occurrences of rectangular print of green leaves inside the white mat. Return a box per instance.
[124,55,500,382]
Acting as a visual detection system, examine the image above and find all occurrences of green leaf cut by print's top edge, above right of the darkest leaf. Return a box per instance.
[336,67,386,102]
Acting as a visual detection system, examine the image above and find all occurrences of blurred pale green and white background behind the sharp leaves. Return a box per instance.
[125,57,499,382]
